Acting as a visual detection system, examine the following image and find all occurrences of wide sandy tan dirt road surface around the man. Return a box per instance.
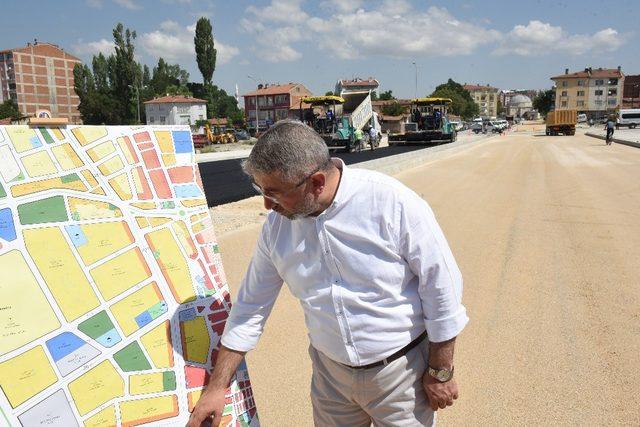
[214,131,640,426]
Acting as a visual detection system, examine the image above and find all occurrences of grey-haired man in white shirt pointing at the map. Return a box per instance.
[188,120,468,427]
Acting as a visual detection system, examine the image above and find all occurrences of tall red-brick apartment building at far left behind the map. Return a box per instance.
[0,40,81,123]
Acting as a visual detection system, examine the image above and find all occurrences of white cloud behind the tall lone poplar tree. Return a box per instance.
[138,20,240,64]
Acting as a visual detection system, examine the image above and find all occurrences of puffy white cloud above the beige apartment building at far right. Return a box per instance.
[494,20,625,56]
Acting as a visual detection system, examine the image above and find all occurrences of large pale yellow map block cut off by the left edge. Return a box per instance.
[0,250,60,355]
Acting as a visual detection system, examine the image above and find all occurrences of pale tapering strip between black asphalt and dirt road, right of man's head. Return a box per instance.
[352,135,500,175]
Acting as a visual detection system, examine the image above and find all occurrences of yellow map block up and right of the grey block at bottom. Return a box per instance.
[69,360,124,415]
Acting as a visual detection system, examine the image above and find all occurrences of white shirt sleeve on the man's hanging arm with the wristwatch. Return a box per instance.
[399,194,469,342]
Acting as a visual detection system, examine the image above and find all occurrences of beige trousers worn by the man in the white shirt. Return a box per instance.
[309,339,436,427]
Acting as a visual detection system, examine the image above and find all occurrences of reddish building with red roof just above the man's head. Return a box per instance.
[242,83,311,129]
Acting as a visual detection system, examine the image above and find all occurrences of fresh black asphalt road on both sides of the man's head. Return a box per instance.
[199,146,425,206]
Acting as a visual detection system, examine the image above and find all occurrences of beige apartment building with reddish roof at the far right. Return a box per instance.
[551,67,624,119]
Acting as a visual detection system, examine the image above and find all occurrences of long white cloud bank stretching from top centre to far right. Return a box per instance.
[240,0,625,62]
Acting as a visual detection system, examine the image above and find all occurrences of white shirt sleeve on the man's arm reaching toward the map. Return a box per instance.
[221,221,283,352]
